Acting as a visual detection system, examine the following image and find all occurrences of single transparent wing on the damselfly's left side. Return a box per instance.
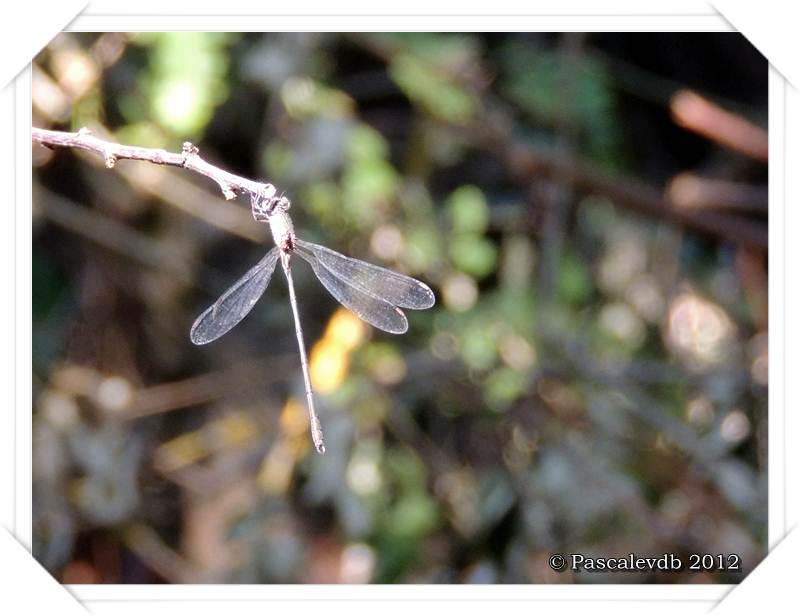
[189,247,280,344]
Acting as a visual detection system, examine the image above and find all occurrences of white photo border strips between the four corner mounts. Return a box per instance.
[3,2,790,613]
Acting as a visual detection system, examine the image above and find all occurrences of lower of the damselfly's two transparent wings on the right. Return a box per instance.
[295,242,408,334]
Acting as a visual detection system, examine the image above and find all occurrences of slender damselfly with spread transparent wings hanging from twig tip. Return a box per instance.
[189,184,436,454]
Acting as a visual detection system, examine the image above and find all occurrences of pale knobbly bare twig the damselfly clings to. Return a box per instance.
[31,126,277,200]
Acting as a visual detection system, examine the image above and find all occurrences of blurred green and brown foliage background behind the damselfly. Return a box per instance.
[32,33,767,583]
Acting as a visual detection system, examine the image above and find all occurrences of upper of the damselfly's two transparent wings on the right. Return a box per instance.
[297,239,436,310]
